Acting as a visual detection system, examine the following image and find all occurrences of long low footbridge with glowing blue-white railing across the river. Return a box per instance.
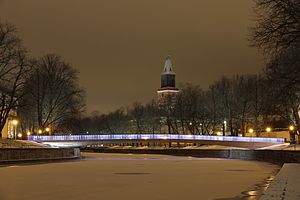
[28,134,284,149]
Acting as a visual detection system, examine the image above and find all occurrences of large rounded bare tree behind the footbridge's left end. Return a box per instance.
[20,54,85,134]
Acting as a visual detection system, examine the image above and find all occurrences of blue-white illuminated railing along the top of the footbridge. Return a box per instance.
[28,134,284,143]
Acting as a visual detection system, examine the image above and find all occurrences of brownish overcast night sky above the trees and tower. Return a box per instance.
[0,0,263,112]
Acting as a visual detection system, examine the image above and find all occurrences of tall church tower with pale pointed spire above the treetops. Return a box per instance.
[157,56,179,106]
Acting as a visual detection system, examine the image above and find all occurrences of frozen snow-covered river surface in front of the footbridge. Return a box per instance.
[0,153,278,200]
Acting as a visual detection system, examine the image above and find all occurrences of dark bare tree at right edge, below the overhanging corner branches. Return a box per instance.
[266,48,300,131]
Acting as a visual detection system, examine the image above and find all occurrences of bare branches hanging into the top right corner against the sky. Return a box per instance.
[251,0,300,55]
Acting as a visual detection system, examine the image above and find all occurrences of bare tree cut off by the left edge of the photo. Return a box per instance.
[0,23,31,137]
